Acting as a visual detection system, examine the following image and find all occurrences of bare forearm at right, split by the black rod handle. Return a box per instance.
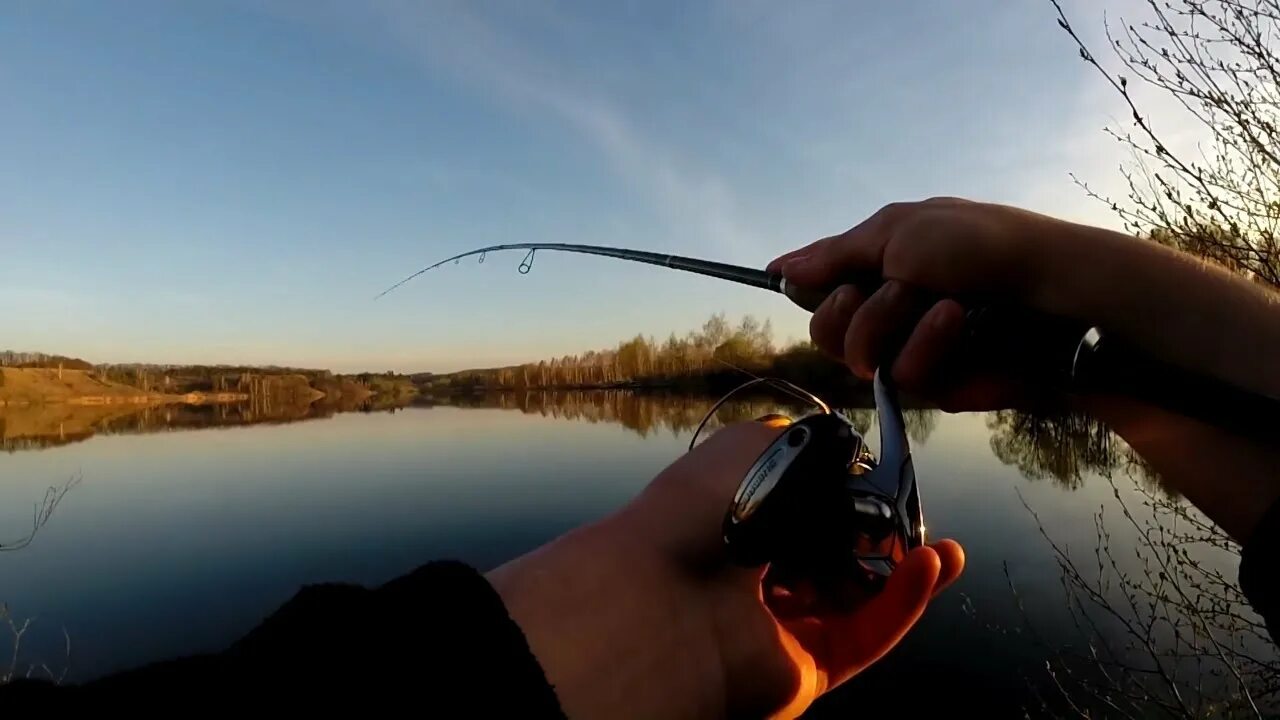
[1029,223,1280,542]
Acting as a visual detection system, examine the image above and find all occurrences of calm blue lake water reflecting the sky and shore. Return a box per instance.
[0,393,1218,714]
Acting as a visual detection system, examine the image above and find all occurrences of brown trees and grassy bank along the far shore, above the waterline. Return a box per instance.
[0,314,864,406]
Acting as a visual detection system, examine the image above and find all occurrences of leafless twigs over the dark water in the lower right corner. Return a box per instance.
[1010,480,1280,719]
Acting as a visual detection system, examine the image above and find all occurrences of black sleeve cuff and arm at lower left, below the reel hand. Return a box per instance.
[0,562,563,717]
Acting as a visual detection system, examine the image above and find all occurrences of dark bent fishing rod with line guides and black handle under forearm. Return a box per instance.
[375,242,1280,439]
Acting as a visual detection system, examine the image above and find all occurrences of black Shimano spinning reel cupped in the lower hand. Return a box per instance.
[723,372,924,589]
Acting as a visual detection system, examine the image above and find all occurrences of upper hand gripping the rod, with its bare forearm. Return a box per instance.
[769,197,1280,410]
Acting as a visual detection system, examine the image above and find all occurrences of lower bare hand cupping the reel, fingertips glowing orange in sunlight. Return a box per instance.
[490,423,964,717]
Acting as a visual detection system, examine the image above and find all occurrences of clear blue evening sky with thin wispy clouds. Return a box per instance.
[0,0,1162,372]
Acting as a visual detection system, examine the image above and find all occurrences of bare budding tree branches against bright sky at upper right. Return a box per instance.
[1050,0,1280,287]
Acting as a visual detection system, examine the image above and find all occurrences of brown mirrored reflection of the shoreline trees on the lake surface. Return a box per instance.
[0,389,1143,489]
